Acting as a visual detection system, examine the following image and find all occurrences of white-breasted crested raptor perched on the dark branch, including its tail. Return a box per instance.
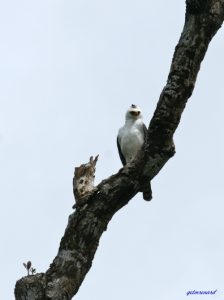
[117,104,152,200]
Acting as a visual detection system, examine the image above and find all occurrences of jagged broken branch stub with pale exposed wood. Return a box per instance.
[73,155,99,208]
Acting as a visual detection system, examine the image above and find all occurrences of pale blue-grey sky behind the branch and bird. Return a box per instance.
[0,0,224,300]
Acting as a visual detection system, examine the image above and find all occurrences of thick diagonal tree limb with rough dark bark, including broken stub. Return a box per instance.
[15,0,224,300]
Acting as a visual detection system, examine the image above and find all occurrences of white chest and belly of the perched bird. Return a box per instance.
[118,124,144,162]
